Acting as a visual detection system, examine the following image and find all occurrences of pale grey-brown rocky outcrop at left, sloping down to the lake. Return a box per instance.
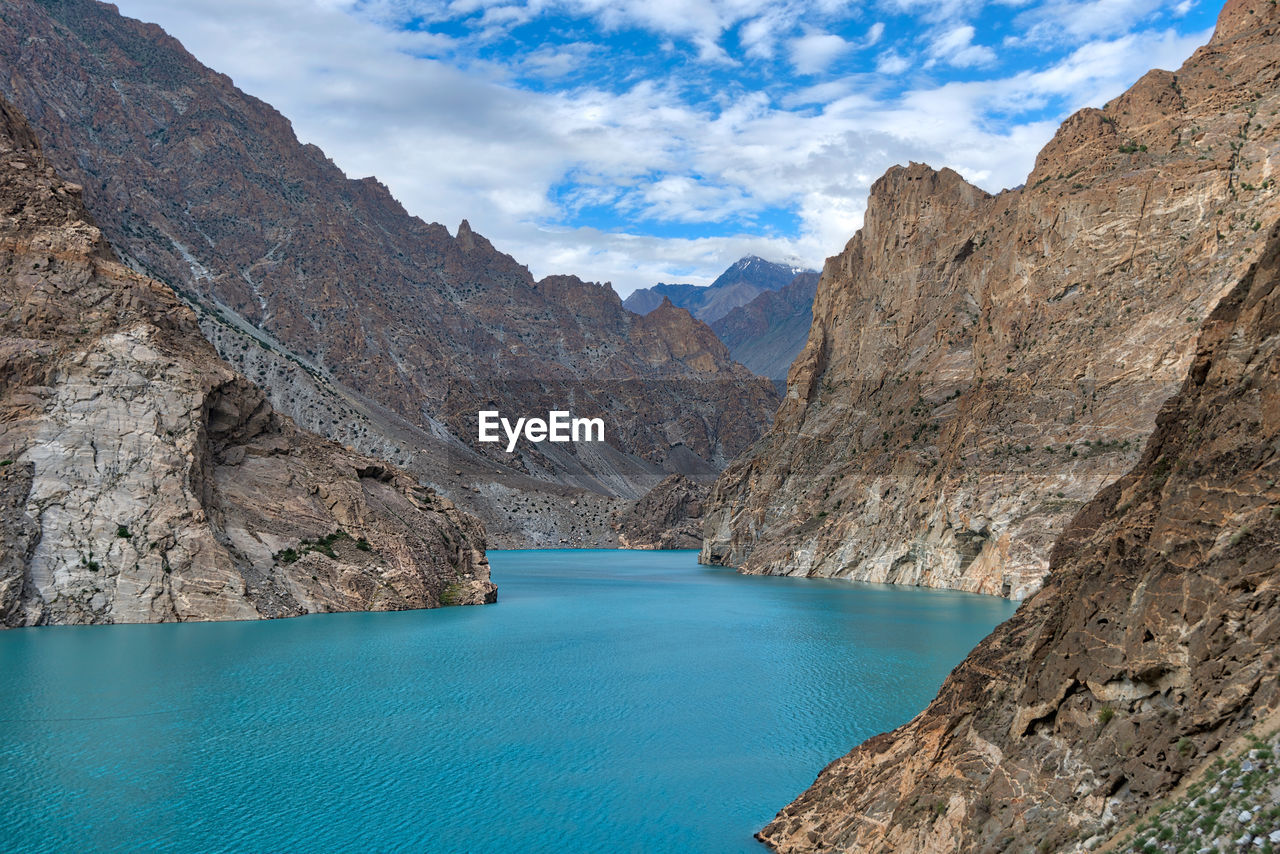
[0,100,495,626]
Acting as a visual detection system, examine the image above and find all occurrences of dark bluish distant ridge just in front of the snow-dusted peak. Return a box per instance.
[712,273,818,384]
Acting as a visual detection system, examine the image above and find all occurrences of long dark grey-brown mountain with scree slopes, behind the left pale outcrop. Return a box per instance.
[0,0,777,544]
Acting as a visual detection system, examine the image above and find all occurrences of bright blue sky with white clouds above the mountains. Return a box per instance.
[116,0,1220,294]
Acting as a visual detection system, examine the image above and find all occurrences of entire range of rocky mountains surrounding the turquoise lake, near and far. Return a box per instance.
[0,0,1280,854]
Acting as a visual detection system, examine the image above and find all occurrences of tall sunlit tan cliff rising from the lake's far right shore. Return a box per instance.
[701,0,1280,598]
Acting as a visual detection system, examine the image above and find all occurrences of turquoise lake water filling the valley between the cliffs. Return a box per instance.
[0,551,1014,854]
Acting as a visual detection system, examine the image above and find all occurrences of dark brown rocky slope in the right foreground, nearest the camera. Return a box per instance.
[762,218,1280,853]
